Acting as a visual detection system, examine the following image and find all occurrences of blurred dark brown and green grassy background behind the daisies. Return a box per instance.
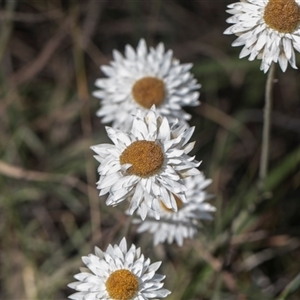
[0,0,300,300]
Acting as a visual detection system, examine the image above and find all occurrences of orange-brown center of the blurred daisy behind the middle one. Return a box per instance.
[131,77,165,109]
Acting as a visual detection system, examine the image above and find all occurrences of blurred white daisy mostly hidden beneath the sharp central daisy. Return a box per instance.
[134,174,216,246]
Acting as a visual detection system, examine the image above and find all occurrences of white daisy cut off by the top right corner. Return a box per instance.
[224,0,300,73]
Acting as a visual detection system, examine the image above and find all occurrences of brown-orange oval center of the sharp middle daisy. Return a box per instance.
[120,140,164,178]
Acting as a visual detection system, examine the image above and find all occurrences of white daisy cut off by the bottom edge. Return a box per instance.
[68,238,170,300]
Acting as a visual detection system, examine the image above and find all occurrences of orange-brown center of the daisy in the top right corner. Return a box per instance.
[264,0,300,33]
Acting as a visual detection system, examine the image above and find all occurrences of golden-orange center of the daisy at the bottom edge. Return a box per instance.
[105,269,139,300]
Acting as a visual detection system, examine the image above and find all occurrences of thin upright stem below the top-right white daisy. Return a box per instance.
[259,63,275,189]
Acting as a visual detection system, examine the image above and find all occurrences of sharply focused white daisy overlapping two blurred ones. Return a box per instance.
[91,107,200,219]
